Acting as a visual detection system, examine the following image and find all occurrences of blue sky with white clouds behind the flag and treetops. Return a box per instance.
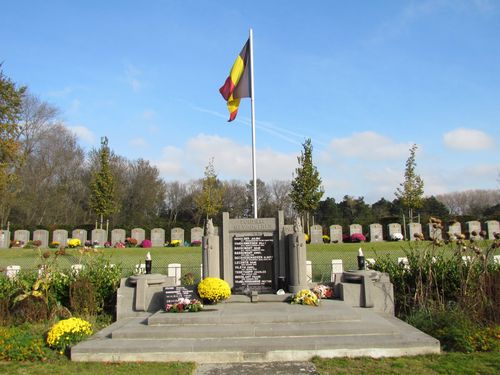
[0,0,500,203]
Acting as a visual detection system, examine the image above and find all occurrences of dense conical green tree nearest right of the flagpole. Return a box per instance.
[290,139,324,233]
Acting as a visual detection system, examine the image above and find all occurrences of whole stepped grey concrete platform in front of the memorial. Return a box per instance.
[71,300,440,363]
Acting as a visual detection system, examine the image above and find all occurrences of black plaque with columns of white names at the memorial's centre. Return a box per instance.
[233,235,274,293]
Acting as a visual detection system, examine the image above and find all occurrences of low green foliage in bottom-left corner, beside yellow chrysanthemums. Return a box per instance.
[0,325,51,361]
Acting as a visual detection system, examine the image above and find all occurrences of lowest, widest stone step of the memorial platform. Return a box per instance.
[71,332,439,363]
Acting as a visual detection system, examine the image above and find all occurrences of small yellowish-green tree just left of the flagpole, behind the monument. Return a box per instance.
[195,158,223,219]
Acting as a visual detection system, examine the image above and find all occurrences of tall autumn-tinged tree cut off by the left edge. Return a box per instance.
[0,64,26,228]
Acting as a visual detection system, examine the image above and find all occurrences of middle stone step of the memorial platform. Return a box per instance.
[111,319,398,339]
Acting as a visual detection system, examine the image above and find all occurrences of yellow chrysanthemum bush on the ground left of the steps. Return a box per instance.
[47,318,92,354]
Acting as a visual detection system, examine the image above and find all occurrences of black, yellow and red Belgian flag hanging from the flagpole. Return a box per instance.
[219,39,251,122]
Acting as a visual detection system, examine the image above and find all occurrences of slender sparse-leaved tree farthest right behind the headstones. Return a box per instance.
[394,144,424,222]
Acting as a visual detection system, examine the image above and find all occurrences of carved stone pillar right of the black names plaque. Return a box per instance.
[288,218,308,293]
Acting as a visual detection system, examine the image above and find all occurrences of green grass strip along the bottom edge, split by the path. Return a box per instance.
[0,352,500,375]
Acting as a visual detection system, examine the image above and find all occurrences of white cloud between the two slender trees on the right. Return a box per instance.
[330,131,410,160]
